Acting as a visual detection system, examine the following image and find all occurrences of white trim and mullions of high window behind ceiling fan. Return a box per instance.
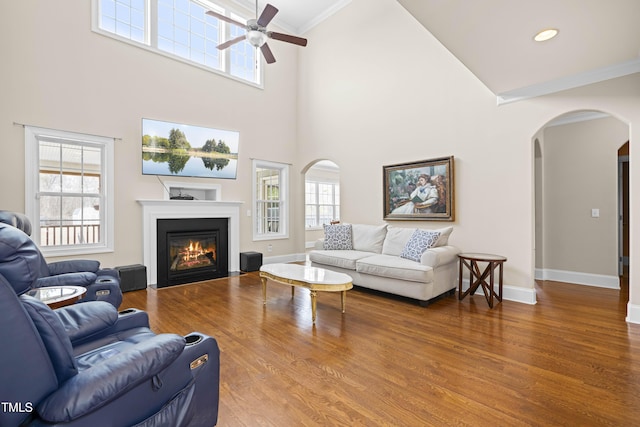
[91,0,266,89]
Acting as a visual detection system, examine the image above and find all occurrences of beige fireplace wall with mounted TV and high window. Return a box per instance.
[0,0,302,266]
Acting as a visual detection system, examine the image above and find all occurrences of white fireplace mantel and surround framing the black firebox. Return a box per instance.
[137,200,244,286]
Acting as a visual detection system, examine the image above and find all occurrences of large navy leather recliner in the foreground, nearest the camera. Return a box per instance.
[0,227,220,427]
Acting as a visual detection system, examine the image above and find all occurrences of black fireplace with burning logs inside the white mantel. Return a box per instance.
[157,218,229,288]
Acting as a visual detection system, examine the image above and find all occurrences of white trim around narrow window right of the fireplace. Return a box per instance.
[251,159,289,241]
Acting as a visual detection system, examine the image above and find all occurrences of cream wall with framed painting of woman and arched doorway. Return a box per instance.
[299,0,640,310]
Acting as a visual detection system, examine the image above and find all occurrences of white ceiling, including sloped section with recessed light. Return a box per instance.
[233,0,640,103]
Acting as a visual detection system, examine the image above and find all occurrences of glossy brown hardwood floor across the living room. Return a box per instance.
[121,273,640,427]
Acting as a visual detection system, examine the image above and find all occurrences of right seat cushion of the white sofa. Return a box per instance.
[356,255,433,283]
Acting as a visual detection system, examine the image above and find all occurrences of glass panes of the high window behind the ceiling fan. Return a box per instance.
[93,0,260,84]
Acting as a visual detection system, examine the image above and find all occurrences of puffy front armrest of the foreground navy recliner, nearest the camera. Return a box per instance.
[37,334,185,423]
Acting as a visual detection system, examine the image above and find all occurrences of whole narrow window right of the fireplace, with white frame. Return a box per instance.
[253,160,289,240]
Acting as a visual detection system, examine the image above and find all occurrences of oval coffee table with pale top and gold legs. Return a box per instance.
[260,264,353,323]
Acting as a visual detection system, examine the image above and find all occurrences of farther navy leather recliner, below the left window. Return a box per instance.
[0,210,122,308]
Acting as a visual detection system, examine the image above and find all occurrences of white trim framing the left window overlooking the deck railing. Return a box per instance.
[24,126,115,257]
